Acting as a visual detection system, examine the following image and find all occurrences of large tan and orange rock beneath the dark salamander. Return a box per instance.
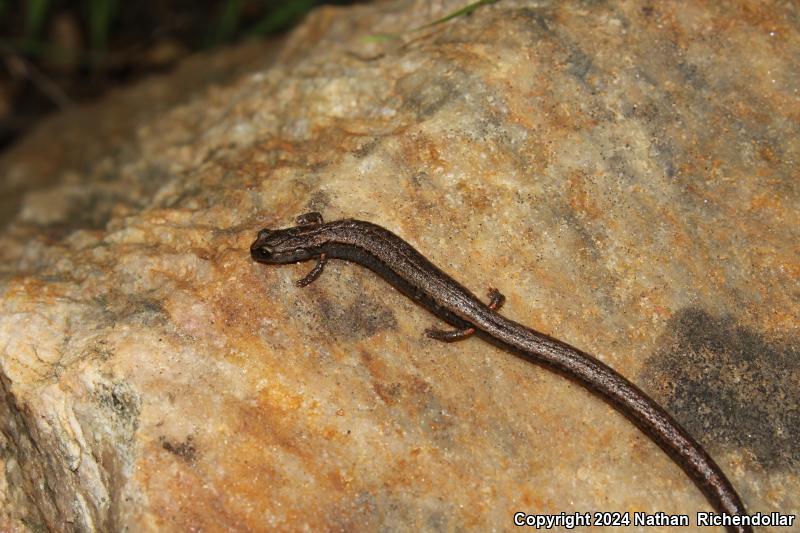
[0,0,800,533]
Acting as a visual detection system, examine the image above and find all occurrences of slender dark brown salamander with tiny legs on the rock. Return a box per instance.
[250,213,752,533]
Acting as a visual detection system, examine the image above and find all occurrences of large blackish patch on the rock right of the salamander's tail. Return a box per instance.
[642,308,800,473]
